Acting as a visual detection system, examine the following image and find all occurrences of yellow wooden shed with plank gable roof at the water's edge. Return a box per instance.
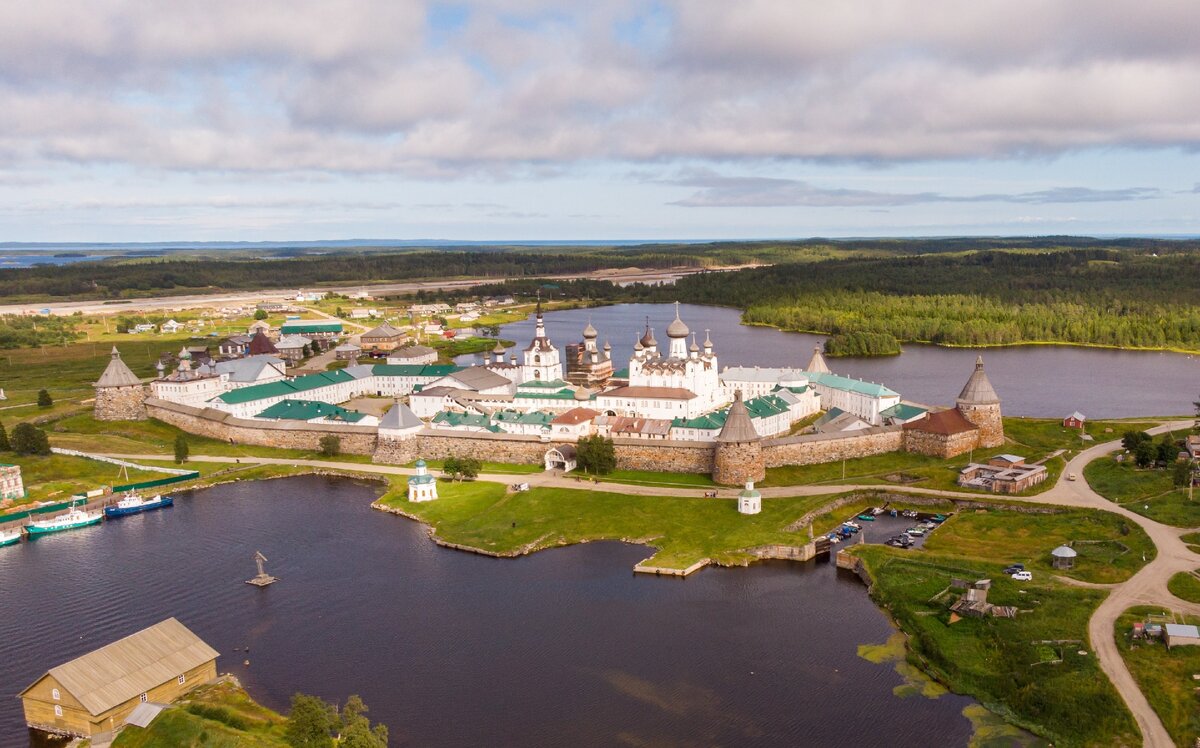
[20,618,217,737]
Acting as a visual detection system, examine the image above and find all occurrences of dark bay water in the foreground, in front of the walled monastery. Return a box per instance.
[0,477,972,746]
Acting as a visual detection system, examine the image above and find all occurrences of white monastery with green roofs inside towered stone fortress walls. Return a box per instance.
[95,304,1003,485]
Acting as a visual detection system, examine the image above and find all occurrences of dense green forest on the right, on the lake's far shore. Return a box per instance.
[463,249,1200,355]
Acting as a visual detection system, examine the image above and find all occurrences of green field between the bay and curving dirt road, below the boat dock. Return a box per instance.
[856,545,1141,747]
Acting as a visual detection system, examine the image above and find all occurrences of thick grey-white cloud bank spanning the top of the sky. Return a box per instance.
[0,0,1200,175]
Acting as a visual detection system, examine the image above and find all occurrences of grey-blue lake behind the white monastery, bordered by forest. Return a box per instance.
[458,304,1200,419]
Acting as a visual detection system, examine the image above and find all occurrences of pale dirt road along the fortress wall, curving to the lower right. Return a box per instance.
[100,420,1200,748]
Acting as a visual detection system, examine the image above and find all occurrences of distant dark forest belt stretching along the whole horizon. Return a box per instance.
[7,237,1200,300]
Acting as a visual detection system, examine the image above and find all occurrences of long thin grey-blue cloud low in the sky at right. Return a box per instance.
[668,170,1160,208]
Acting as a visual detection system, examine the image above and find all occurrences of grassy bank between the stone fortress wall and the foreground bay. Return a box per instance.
[382,478,829,568]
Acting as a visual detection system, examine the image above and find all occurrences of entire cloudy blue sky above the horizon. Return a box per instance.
[0,0,1200,243]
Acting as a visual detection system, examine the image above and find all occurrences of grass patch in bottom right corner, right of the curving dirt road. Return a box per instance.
[1112,606,1200,748]
